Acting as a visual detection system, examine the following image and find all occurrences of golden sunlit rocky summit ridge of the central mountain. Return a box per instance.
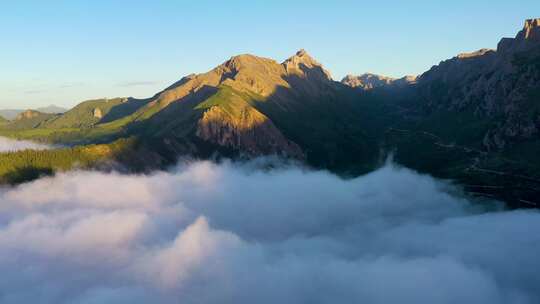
[143,50,336,119]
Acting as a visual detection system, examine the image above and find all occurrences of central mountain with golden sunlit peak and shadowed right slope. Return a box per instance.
[125,50,378,167]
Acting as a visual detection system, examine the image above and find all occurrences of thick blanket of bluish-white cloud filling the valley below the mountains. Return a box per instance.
[0,162,540,304]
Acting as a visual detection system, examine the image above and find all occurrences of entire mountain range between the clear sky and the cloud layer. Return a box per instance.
[0,19,540,206]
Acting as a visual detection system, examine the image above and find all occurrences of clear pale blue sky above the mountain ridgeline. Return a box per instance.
[0,0,540,108]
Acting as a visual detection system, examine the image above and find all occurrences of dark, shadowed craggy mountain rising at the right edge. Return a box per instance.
[375,19,540,205]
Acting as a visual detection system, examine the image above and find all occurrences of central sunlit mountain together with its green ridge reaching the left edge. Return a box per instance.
[0,50,379,174]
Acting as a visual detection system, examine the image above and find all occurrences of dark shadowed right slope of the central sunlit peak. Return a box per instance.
[254,64,390,176]
